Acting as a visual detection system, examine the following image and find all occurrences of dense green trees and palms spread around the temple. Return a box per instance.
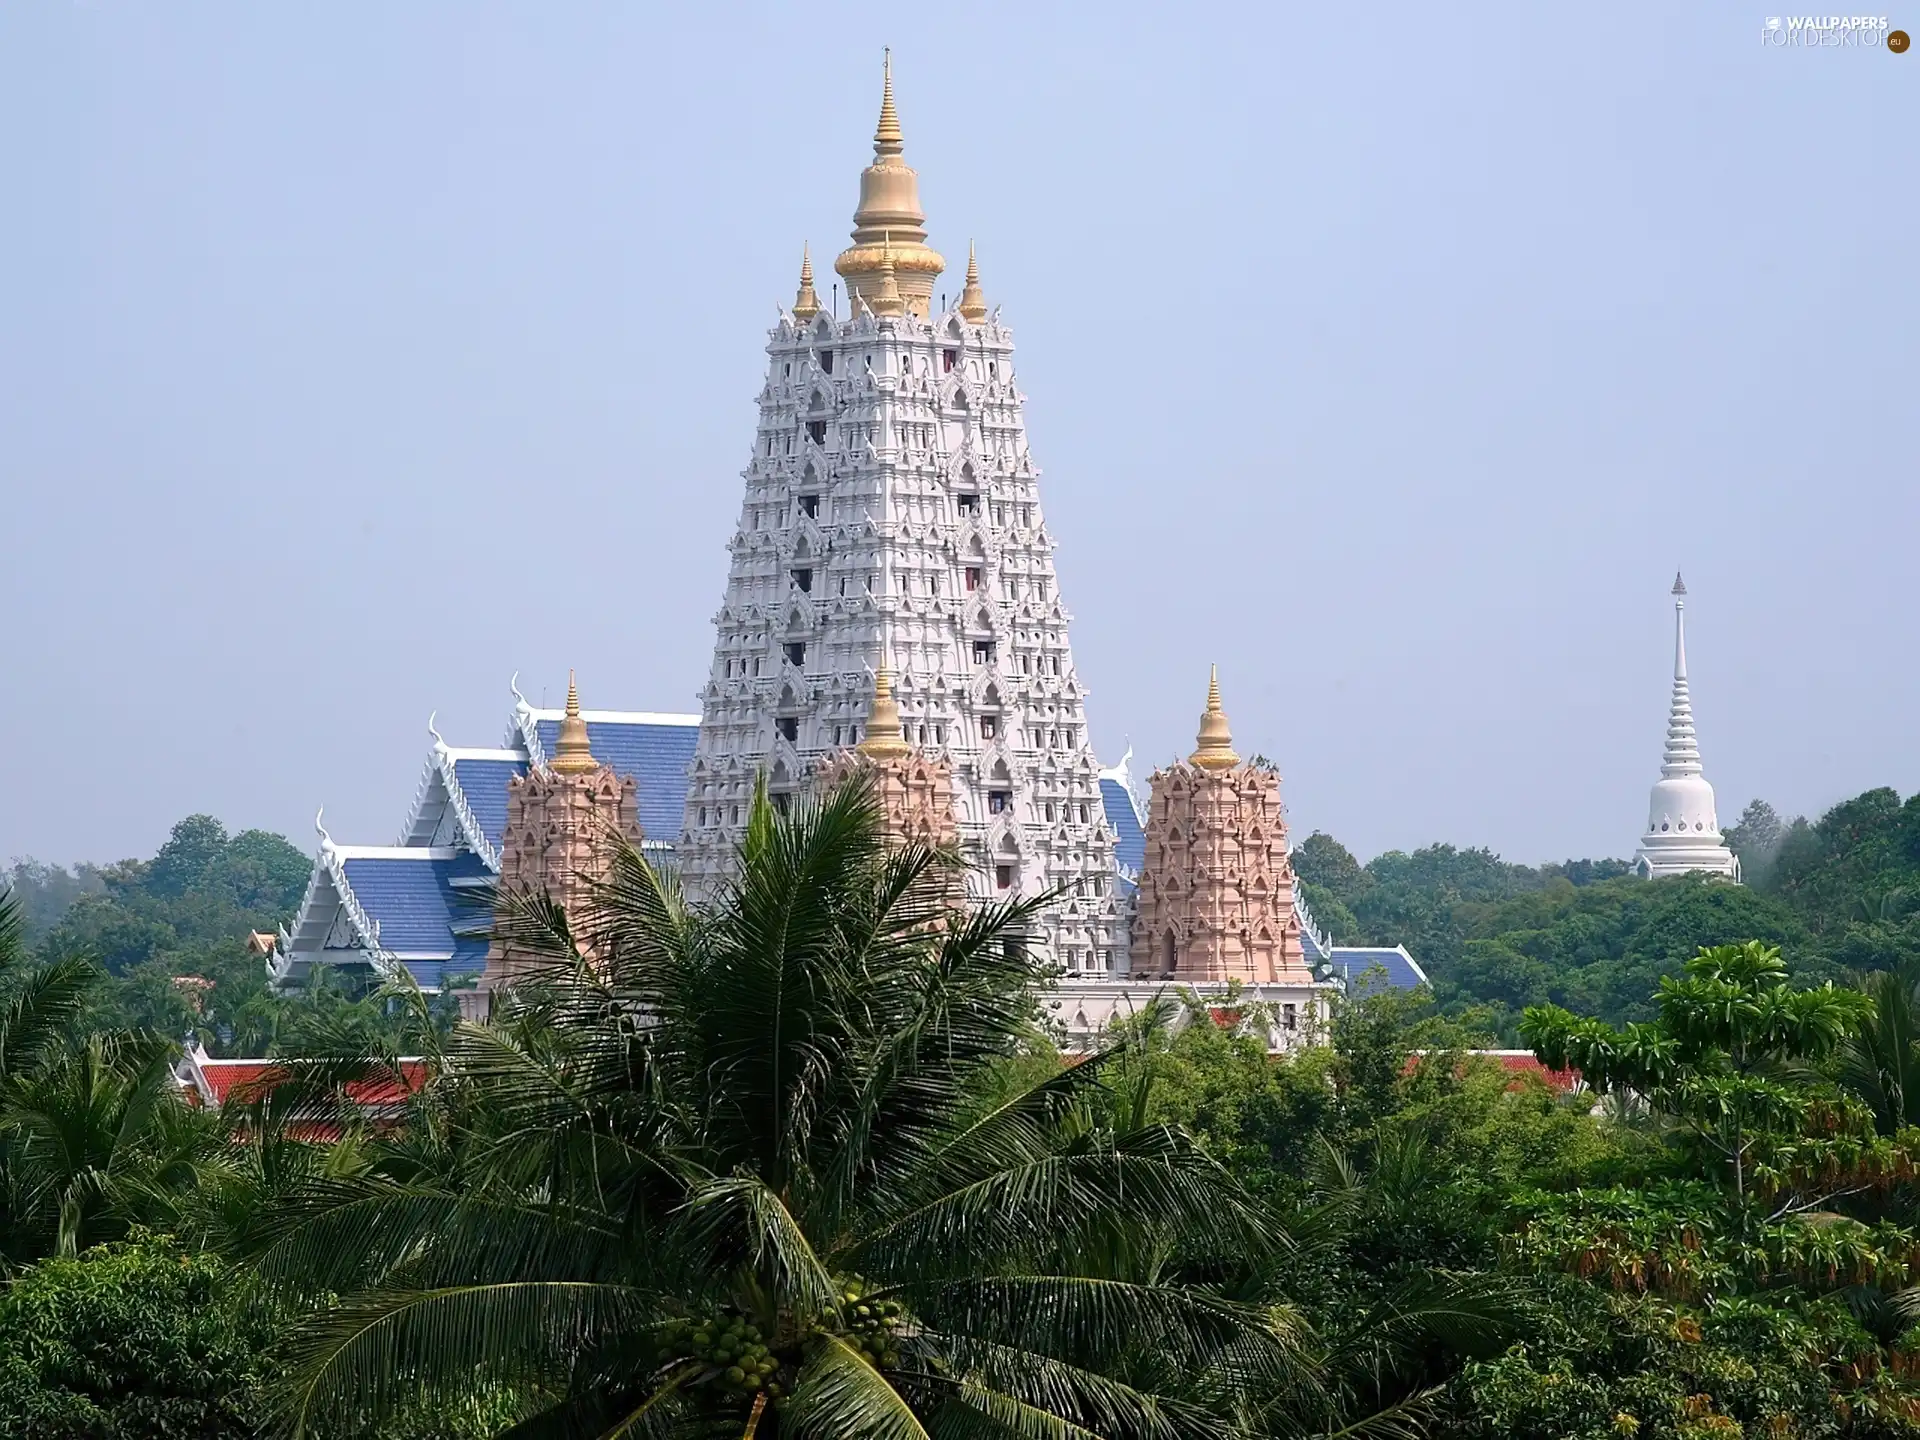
[0,791,1920,1440]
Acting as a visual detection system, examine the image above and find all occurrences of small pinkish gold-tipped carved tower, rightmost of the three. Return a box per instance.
[1133,676,1313,985]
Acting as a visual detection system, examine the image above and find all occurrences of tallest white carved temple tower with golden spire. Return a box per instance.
[678,65,1127,973]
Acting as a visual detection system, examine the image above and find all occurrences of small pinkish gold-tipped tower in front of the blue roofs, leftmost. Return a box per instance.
[480,676,641,991]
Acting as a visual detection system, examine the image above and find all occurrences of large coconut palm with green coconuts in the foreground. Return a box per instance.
[240,785,1300,1440]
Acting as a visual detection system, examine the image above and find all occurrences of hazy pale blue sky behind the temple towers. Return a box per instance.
[0,0,1920,860]
